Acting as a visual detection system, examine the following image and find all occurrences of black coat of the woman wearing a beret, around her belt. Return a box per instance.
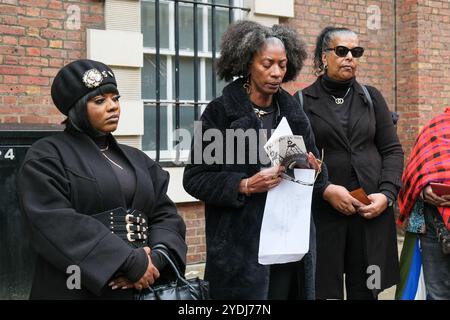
[19,130,187,299]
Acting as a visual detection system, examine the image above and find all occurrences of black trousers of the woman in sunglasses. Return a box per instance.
[316,214,377,300]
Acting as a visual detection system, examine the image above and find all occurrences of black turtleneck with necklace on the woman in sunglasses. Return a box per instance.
[320,74,355,137]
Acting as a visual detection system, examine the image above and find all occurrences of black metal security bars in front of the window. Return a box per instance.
[144,0,249,161]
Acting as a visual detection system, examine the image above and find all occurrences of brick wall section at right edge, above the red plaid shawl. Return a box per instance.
[399,0,450,159]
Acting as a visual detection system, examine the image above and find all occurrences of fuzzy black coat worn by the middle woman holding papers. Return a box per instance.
[183,79,326,299]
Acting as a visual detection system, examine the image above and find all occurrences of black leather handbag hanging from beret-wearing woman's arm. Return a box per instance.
[134,244,210,300]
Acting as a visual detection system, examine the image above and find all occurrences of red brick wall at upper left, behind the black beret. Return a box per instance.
[0,0,104,123]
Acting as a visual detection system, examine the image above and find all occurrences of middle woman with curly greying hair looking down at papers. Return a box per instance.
[183,21,327,299]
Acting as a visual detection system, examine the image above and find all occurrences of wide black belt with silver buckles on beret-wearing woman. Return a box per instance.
[92,207,148,248]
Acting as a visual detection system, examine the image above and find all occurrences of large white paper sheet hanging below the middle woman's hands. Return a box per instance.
[258,169,314,265]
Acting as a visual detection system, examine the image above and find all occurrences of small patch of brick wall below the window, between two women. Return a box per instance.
[177,202,206,263]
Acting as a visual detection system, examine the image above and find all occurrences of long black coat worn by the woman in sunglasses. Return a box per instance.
[303,78,403,298]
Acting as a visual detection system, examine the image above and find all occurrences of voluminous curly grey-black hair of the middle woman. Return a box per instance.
[216,20,307,82]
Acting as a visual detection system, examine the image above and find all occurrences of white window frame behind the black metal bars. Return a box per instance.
[143,0,244,162]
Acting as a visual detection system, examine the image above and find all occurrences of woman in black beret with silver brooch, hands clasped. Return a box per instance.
[19,60,187,299]
